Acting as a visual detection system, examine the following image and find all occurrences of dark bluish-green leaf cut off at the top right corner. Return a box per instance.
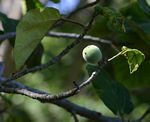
[138,0,150,16]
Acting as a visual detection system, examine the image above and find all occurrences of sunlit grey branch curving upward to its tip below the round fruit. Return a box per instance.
[1,71,99,101]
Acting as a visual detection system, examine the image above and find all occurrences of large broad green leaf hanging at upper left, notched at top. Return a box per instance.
[14,8,60,69]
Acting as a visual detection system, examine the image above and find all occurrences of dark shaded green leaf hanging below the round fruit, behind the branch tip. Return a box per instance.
[86,64,133,115]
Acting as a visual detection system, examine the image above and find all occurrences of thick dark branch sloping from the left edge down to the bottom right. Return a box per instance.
[0,81,120,122]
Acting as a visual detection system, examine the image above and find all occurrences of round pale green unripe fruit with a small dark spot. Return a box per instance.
[82,45,102,64]
